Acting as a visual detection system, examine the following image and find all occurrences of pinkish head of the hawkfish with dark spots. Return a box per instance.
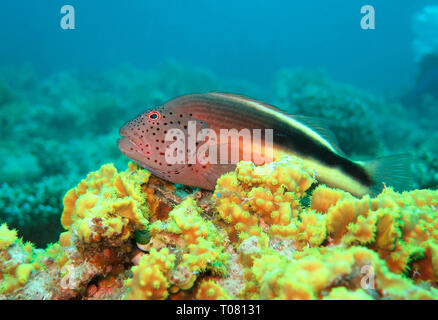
[117,105,212,185]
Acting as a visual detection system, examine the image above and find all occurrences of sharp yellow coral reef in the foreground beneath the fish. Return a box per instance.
[0,156,438,300]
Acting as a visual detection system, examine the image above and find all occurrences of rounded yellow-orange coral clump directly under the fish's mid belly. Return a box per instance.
[212,156,313,241]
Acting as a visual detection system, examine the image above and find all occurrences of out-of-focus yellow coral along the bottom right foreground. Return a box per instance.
[251,247,438,299]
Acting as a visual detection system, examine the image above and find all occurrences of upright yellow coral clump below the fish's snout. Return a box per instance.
[61,164,150,244]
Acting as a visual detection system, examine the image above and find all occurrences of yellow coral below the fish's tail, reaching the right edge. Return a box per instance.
[318,188,438,281]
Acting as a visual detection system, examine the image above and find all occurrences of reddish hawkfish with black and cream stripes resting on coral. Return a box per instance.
[117,92,410,197]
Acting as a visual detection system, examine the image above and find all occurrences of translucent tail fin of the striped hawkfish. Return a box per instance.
[365,154,413,196]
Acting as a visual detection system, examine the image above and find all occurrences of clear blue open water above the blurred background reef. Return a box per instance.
[0,0,437,91]
